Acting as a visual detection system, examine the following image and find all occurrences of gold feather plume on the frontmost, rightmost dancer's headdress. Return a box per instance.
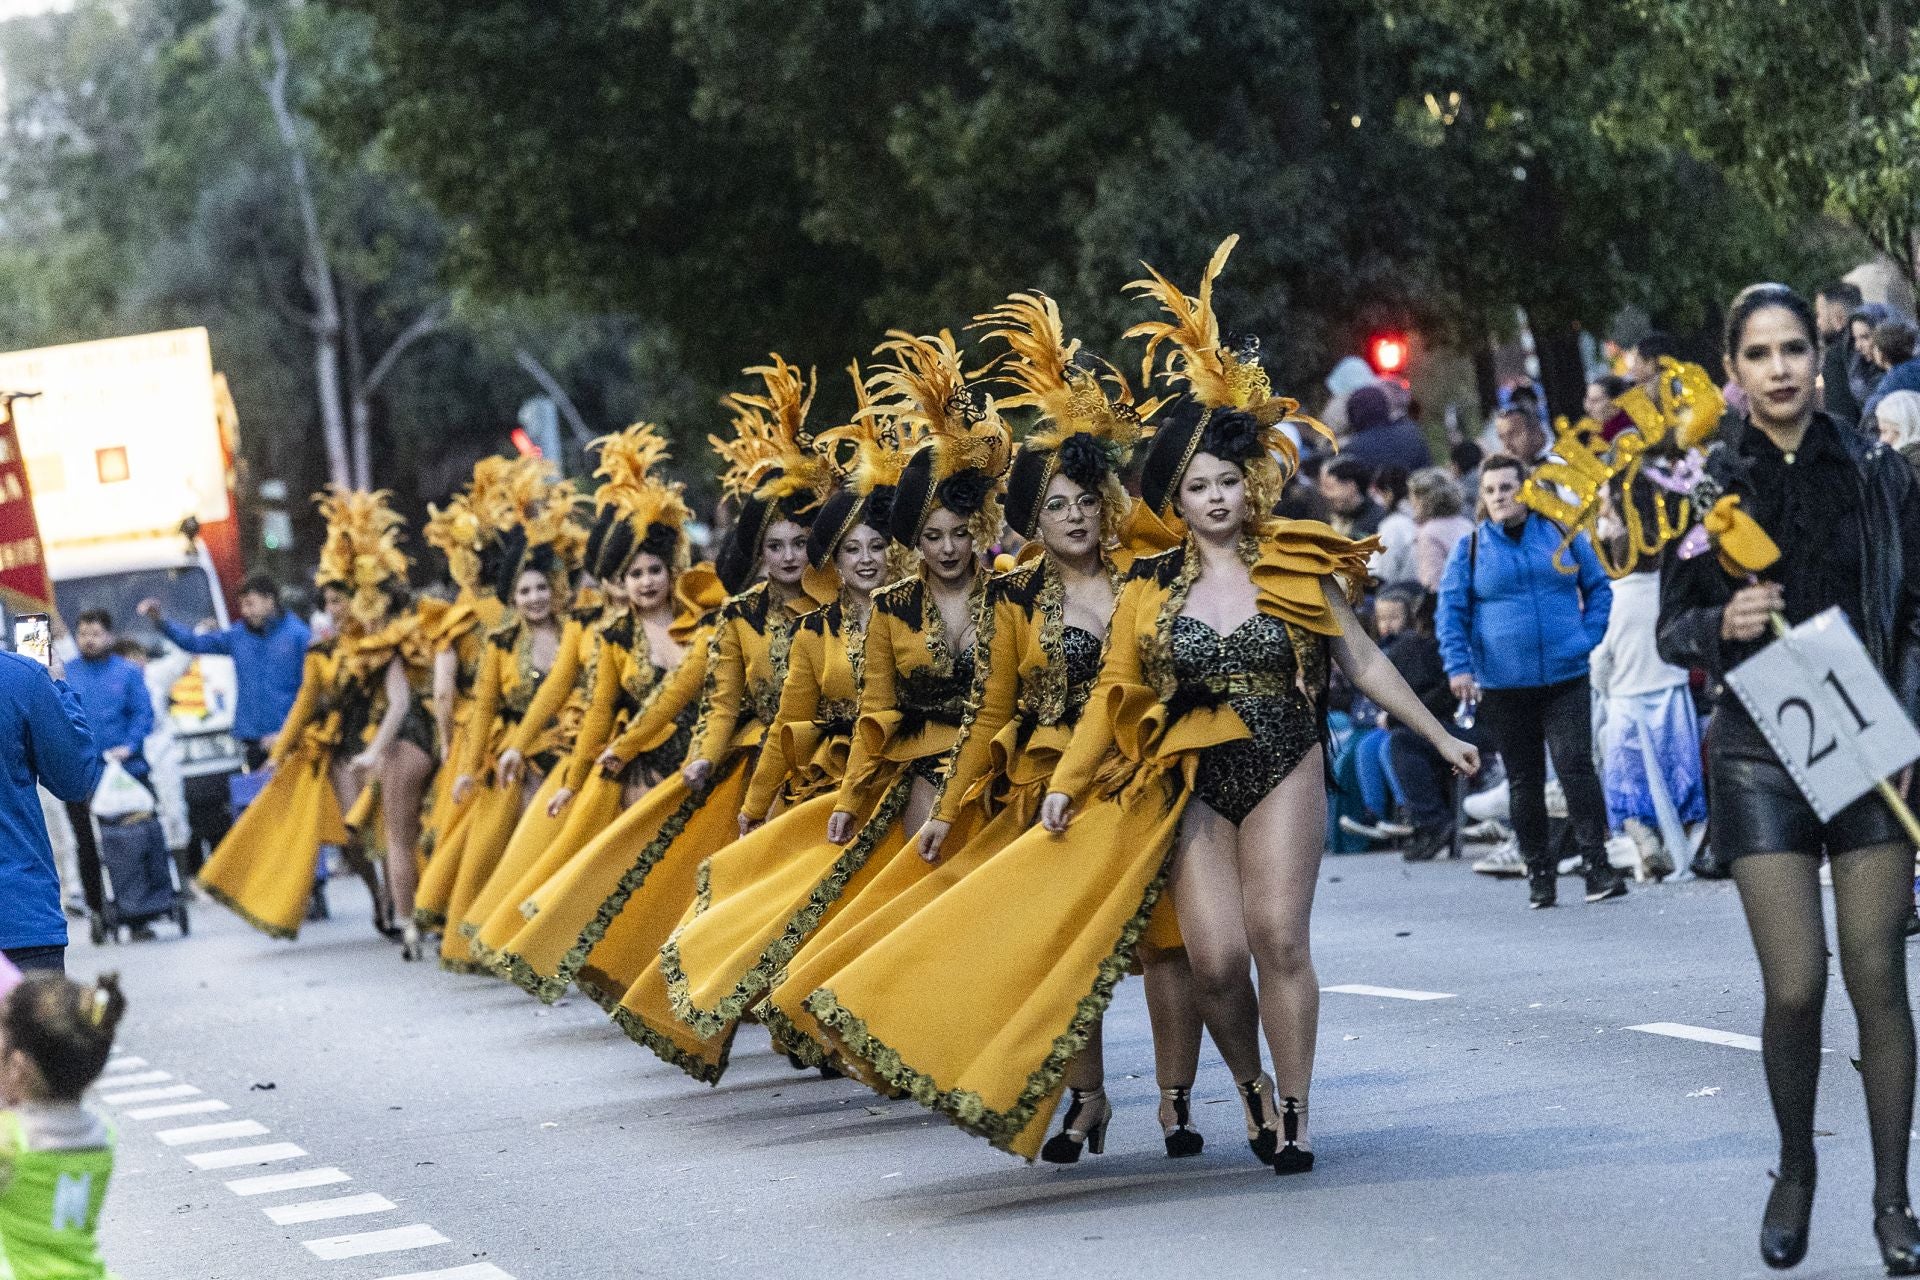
[1123,234,1332,450]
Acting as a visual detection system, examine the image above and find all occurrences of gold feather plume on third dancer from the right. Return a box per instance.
[868,328,1014,482]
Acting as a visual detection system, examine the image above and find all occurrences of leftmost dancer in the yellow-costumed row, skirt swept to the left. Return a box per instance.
[200,487,434,938]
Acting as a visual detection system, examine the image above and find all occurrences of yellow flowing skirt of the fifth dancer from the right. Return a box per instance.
[495,758,747,1004]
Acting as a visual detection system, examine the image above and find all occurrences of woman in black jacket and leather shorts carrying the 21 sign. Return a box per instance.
[1659,284,1920,1276]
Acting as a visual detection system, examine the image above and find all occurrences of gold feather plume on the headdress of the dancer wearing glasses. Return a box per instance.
[973,292,1160,466]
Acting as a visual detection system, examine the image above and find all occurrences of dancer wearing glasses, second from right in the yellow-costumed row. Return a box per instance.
[802,296,1204,1163]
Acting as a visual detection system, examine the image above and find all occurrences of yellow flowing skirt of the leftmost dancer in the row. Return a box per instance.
[200,750,348,938]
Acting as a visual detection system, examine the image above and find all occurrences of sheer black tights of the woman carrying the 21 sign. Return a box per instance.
[1734,844,1914,1207]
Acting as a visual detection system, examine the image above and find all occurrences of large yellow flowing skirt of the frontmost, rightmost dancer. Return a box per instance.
[794,775,1188,1159]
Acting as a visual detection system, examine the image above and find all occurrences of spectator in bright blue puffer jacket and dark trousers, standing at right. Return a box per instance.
[1436,455,1626,908]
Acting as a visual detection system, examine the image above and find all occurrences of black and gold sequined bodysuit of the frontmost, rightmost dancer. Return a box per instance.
[1173,614,1319,825]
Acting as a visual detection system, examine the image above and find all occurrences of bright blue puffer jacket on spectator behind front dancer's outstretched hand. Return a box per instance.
[1436,516,1613,689]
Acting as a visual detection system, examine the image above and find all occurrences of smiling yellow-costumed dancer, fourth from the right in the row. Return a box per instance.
[612,365,918,1082]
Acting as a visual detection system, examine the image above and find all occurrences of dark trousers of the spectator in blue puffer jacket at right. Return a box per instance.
[1480,676,1607,875]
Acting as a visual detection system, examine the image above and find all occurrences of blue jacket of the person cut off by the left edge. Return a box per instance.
[0,652,104,948]
